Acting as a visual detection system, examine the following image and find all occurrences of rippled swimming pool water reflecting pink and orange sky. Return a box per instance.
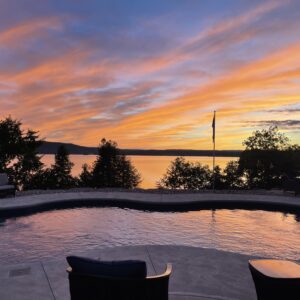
[0,208,300,263]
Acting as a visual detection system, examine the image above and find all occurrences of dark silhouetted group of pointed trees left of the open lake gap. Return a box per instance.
[0,117,141,190]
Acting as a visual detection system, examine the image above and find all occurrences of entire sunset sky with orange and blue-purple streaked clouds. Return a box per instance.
[0,0,300,149]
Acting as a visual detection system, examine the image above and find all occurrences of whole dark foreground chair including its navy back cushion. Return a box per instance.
[67,255,172,300]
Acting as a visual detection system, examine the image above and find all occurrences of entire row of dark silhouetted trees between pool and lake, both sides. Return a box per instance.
[0,117,300,190]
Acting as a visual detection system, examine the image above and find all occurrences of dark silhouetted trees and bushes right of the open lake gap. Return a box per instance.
[158,126,300,190]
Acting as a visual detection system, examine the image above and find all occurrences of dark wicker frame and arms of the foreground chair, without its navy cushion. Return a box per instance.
[67,258,172,300]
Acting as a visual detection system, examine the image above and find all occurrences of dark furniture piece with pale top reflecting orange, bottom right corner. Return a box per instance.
[249,260,300,300]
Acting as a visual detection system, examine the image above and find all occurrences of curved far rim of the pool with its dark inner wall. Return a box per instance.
[0,191,300,217]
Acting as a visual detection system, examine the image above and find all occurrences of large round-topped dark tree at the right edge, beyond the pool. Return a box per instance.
[239,126,300,188]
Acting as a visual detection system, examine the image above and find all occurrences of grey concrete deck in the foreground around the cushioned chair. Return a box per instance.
[0,246,262,300]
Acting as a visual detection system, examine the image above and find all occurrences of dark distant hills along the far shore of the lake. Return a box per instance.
[39,141,241,157]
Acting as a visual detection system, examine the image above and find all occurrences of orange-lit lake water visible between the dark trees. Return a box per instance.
[42,155,238,188]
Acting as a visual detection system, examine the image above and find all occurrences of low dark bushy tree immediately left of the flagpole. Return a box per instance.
[157,157,212,190]
